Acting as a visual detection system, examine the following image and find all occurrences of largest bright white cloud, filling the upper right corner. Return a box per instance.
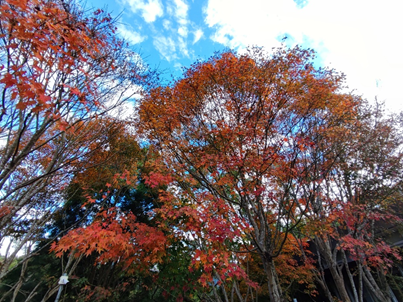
[204,0,403,108]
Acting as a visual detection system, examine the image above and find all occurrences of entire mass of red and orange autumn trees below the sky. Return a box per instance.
[0,0,403,302]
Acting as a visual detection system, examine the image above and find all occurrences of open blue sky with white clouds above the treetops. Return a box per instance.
[86,0,403,111]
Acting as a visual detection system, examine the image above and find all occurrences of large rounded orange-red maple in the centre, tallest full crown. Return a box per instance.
[139,47,360,301]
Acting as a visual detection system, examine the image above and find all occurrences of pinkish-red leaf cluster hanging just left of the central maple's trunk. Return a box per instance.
[155,192,252,287]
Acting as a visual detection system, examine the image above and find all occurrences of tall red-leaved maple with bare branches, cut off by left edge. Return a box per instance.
[0,0,144,279]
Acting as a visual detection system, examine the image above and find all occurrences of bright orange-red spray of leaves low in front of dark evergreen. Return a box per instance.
[51,208,166,269]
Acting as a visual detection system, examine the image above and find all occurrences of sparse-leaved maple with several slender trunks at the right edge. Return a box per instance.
[307,104,403,301]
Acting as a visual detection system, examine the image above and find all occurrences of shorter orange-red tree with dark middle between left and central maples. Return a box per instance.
[44,134,169,301]
